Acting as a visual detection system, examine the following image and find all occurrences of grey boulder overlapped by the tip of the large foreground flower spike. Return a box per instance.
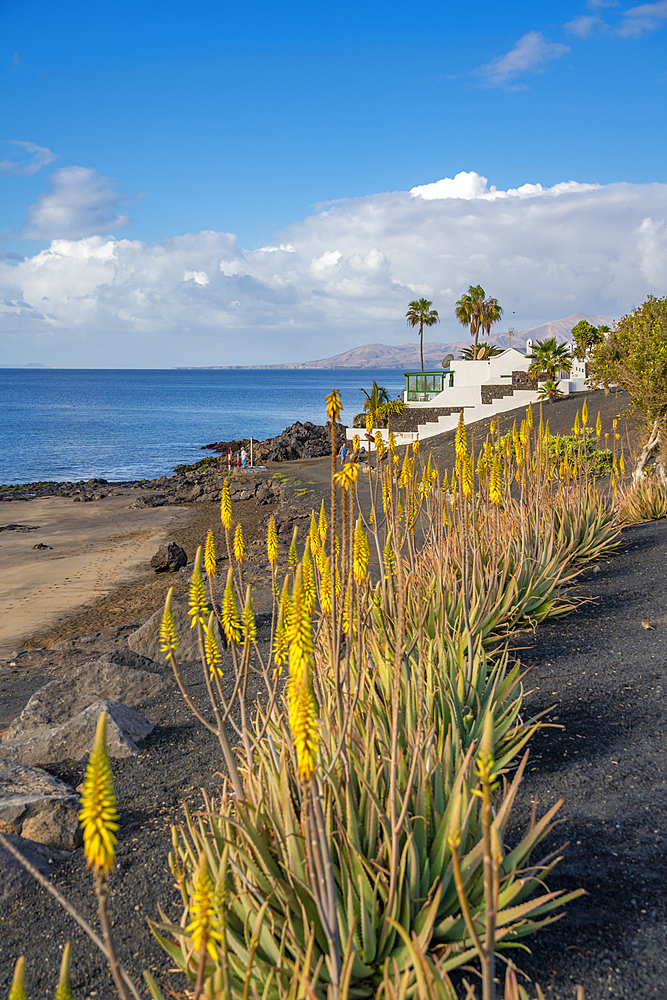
[0,699,154,765]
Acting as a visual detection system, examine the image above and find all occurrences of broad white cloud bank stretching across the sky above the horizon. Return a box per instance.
[0,171,667,366]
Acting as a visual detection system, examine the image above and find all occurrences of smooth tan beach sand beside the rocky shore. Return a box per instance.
[0,491,192,657]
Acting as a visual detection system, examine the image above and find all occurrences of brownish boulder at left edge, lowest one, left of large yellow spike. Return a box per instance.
[0,758,81,851]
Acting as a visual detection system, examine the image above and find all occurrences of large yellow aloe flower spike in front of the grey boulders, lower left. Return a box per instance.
[79,712,120,878]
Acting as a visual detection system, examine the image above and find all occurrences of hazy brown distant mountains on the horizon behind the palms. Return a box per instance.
[185,313,614,369]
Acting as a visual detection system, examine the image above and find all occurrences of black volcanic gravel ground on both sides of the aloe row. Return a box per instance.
[0,392,667,1000]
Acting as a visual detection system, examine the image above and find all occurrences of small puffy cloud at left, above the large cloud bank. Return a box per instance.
[21,167,130,240]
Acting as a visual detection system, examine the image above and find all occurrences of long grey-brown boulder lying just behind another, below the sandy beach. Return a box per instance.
[0,653,166,744]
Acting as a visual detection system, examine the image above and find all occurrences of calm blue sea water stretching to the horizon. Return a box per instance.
[0,369,404,484]
